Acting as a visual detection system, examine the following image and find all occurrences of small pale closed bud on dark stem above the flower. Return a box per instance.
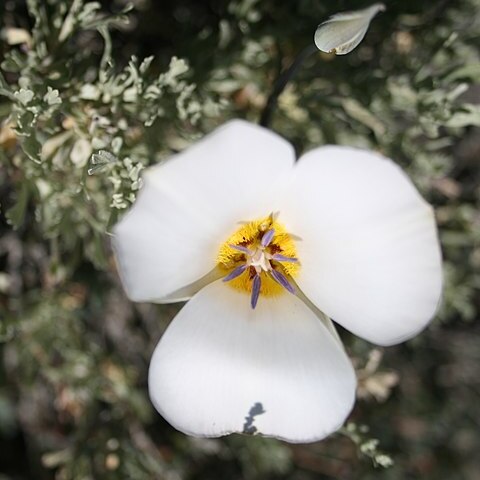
[315,3,385,55]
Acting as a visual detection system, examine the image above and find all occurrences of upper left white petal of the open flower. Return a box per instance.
[113,120,295,301]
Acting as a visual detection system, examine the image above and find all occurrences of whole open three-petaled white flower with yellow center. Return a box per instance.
[114,121,442,442]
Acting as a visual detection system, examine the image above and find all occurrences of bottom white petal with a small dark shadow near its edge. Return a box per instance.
[149,281,356,442]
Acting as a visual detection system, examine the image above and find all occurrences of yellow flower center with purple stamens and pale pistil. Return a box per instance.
[217,215,300,308]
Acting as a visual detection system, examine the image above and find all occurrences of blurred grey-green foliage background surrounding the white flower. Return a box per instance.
[0,0,480,480]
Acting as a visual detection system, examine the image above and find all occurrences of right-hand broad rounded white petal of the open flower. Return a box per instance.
[280,147,442,345]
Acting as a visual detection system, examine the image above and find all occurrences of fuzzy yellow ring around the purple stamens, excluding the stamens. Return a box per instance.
[217,215,300,296]
